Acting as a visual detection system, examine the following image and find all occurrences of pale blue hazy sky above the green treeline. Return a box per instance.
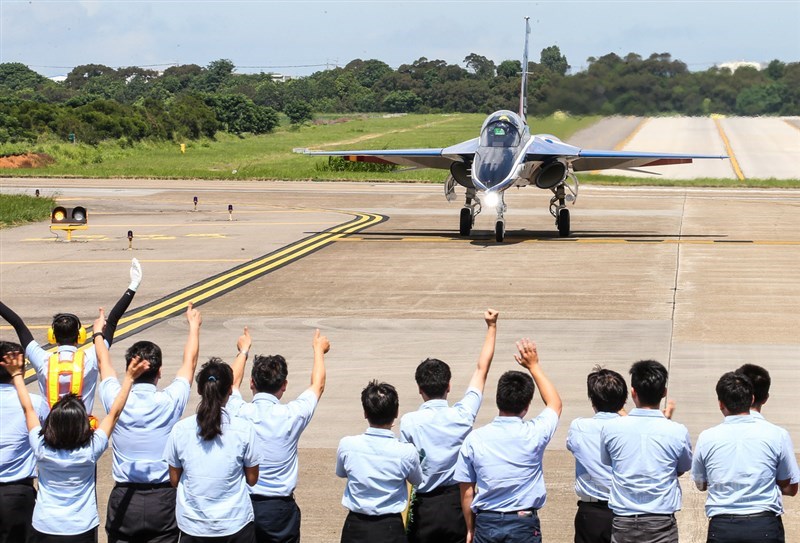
[0,0,800,77]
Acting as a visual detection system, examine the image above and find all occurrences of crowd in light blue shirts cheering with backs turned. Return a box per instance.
[0,259,800,543]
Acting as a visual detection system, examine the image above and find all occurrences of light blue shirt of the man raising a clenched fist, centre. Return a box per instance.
[400,387,483,492]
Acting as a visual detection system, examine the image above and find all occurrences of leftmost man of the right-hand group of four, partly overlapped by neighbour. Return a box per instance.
[567,367,628,543]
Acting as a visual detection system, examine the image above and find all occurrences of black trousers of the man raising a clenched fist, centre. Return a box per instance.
[408,485,467,543]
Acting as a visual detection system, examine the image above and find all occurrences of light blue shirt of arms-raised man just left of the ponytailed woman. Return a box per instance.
[100,377,191,483]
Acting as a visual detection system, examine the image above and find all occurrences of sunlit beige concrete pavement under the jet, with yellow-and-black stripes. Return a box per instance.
[0,177,800,541]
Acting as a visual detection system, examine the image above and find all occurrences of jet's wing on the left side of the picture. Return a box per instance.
[295,138,478,170]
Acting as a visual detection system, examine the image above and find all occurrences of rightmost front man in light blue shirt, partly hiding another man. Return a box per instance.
[692,372,800,543]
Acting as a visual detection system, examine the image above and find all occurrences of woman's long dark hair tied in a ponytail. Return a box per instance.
[197,357,233,441]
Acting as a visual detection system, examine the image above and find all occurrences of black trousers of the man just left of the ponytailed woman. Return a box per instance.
[106,483,180,543]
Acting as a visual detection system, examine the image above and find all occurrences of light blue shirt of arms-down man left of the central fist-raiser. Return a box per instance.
[336,428,422,515]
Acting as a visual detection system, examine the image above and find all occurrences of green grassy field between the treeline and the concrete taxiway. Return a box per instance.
[0,114,800,188]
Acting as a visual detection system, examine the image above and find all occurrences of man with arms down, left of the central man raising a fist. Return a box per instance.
[336,381,422,543]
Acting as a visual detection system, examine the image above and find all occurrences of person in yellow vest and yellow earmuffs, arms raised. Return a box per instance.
[0,258,142,414]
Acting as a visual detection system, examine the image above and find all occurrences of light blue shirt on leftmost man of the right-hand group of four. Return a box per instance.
[567,411,619,501]
